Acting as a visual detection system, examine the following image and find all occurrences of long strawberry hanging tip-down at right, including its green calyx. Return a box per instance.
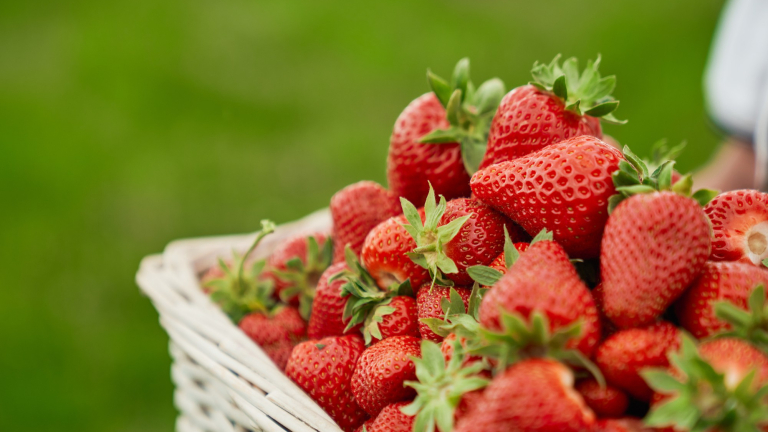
[600,147,713,328]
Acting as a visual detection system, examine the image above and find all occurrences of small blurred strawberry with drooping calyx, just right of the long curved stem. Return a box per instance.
[267,233,333,319]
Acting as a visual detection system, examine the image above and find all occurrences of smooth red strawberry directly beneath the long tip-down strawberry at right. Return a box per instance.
[595,321,680,401]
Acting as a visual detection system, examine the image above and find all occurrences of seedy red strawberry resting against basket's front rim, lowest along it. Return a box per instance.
[285,335,368,432]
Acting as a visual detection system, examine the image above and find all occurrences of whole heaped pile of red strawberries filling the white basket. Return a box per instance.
[203,58,768,432]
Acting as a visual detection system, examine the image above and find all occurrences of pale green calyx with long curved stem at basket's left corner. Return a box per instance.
[204,220,275,323]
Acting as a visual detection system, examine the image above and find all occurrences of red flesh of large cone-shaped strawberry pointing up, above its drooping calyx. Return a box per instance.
[480,240,600,357]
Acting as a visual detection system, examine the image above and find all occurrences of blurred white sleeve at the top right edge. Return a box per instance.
[704,0,768,140]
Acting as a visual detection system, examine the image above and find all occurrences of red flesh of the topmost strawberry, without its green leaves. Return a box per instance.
[480,85,603,168]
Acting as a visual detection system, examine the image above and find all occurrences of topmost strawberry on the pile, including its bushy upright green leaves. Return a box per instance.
[480,55,619,169]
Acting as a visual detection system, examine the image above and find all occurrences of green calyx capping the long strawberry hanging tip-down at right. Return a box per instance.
[608,146,718,213]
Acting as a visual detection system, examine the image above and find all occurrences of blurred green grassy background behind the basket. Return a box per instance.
[0,0,722,431]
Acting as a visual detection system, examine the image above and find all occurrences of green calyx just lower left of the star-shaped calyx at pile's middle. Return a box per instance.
[328,246,413,345]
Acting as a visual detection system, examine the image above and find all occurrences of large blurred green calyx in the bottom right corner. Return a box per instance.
[641,334,768,432]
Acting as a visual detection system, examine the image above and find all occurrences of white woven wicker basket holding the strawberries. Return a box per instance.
[136,210,341,432]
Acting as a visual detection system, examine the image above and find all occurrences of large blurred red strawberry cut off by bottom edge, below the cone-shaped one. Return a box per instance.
[454,359,595,432]
